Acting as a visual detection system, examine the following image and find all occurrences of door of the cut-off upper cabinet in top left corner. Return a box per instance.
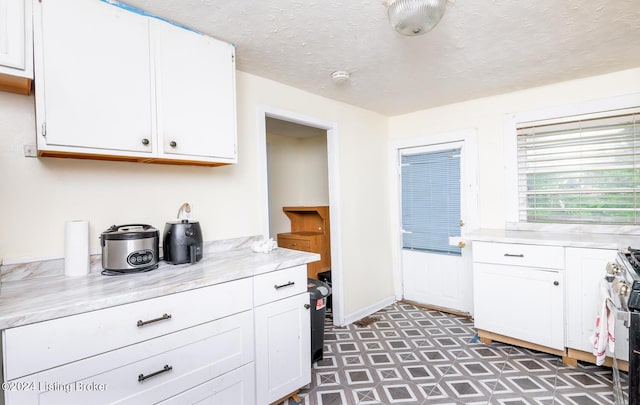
[0,0,28,69]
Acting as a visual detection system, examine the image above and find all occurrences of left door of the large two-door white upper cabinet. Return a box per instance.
[35,0,154,154]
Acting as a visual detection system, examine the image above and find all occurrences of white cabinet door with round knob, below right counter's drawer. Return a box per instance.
[473,263,564,350]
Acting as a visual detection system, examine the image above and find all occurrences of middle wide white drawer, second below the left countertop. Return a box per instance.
[9,311,254,405]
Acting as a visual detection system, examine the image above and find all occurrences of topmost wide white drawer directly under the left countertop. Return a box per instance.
[3,279,253,380]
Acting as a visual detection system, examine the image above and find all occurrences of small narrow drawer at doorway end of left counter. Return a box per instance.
[253,266,307,306]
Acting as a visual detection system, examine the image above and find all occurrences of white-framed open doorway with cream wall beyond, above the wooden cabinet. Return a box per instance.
[257,107,345,326]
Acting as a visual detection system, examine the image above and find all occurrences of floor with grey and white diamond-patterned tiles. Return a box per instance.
[285,303,627,405]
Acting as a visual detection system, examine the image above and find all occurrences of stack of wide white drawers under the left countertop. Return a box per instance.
[2,278,255,405]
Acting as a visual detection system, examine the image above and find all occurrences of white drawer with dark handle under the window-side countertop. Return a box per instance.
[473,242,564,270]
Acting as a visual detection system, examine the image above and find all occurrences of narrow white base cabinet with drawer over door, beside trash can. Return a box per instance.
[254,266,311,405]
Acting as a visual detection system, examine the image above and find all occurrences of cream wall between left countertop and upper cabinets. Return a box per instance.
[0,92,260,260]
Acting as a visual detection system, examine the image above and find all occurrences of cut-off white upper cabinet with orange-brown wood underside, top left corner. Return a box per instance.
[0,0,33,94]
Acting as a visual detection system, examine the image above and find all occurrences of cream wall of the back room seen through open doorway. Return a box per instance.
[267,134,329,238]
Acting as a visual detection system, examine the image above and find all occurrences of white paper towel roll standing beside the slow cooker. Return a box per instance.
[64,220,89,277]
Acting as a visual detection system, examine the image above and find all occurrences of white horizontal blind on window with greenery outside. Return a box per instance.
[517,108,640,225]
